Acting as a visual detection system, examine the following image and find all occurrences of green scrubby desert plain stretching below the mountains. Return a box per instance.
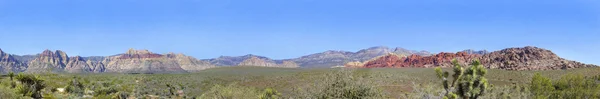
[0,63,600,99]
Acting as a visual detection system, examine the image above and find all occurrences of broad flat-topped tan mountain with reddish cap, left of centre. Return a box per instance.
[102,49,213,73]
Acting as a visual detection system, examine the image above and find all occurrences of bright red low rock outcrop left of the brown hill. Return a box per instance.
[364,52,480,68]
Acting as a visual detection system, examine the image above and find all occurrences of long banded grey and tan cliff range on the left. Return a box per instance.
[0,49,214,73]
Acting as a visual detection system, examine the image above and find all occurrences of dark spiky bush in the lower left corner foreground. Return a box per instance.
[16,73,46,99]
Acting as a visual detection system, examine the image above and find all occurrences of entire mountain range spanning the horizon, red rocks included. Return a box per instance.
[0,46,595,73]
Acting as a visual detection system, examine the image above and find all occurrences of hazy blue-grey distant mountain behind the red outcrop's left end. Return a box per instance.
[288,46,431,68]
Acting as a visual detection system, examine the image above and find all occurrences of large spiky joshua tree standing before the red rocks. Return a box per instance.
[435,60,488,99]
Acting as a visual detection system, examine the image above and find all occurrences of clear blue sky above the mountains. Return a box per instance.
[0,0,600,65]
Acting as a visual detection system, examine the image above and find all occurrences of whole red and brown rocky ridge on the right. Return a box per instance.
[362,46,595,70]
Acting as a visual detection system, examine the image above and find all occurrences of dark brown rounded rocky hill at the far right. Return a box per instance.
[481,46,594,70]
